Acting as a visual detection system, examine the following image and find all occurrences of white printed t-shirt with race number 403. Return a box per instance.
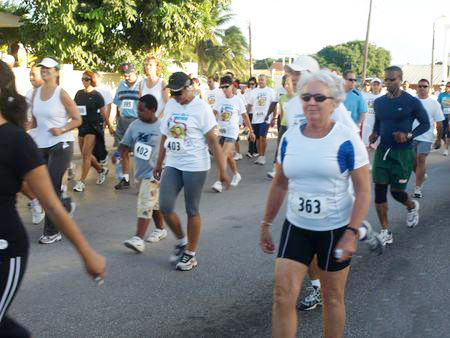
[161,97,217,171]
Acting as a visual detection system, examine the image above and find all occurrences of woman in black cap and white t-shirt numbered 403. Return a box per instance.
[154,72,229,271]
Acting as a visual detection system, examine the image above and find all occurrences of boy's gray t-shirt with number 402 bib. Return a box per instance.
[120,119,161,180]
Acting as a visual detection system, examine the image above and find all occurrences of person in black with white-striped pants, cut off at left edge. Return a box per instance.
[0,61,105,337]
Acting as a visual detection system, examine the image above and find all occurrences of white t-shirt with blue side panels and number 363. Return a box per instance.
[277,122,369,231]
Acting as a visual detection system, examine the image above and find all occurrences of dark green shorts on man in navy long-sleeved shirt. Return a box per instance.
[372,147,415,190]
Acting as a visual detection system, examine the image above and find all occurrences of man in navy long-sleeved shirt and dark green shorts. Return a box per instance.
[369,66,430,244]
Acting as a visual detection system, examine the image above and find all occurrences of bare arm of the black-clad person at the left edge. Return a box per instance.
[25,165,105,278]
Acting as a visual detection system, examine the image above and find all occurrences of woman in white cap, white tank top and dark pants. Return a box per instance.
[32,58,81,244]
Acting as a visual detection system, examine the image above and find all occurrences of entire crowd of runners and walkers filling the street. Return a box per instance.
[0,55,450,337]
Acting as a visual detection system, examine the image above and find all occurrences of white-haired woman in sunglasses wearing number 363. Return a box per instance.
[260,70,370,337]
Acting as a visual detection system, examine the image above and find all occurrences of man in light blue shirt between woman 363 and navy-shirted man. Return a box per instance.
[343,70,367,128]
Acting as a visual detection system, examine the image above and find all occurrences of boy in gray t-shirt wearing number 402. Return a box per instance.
[119,95,167,253]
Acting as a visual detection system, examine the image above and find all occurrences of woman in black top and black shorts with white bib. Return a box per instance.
[73,70,114,192]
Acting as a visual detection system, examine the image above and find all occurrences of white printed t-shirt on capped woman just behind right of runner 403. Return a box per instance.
[213,95,246,139]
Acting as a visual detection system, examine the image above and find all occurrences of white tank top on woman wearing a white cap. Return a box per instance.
[33,86,75,148]
